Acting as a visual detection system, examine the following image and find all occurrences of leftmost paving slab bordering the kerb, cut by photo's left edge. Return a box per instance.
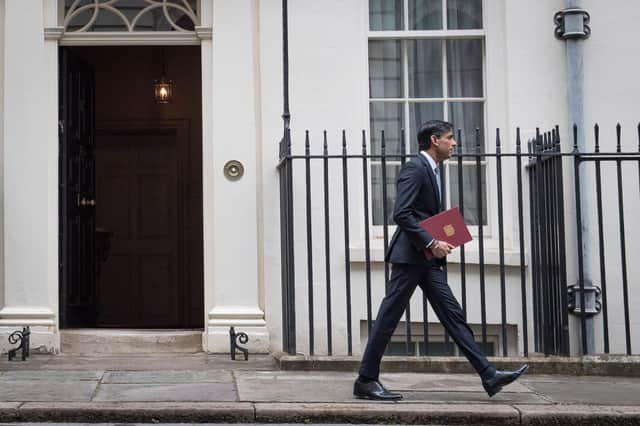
[0,380,98,401]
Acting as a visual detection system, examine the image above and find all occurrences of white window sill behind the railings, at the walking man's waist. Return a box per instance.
[349,244,528,267]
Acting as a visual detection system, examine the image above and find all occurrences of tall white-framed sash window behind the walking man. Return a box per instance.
[369,0,487,225]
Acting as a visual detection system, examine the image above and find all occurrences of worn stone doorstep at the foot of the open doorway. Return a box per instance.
[60,328,202,355]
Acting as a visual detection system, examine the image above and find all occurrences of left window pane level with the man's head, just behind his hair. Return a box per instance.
[369,102,404,155]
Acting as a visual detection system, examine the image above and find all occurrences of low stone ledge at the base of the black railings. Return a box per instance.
[273,353,640,377]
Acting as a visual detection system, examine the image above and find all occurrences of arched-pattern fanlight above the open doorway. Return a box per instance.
[63,0,199,33]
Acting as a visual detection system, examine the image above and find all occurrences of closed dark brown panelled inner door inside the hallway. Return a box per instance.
[96,129,185,328]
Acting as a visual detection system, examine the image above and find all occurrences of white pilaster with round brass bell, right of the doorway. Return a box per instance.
[203,0,269,352]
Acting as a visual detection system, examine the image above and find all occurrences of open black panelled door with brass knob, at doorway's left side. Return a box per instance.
[59,48,96,327]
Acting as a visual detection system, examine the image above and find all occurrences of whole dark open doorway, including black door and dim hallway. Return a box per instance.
[60,46,204,328]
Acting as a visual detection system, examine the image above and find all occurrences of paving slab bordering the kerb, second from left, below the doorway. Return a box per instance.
[93,383,237,402]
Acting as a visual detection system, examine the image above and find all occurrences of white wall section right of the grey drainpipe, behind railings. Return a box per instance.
[583,0,640,353]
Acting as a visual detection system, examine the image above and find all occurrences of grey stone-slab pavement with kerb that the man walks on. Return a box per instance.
[0,353,640,425]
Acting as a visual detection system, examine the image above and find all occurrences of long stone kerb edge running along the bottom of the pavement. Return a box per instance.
[0,402,640,425]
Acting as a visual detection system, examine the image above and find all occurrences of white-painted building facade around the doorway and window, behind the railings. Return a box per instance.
[0,0,640,354]
